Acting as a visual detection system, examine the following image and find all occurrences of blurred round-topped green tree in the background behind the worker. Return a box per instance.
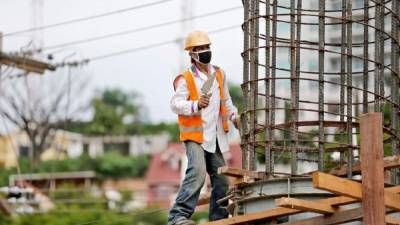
[67,86,181,142]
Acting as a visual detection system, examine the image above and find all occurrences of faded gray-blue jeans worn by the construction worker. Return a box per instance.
[168,141,229,225]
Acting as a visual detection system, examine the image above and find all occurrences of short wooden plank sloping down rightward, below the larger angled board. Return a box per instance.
[275,198,336,214]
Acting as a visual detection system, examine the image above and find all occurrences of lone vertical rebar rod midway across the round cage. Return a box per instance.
[318,0,325,171]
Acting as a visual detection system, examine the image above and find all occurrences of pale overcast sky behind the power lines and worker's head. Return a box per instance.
[0,0,243,122]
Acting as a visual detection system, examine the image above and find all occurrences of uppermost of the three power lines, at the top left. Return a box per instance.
[3,0,172,37]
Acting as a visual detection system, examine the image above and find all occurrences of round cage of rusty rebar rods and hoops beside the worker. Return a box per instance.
[240,0,400,180]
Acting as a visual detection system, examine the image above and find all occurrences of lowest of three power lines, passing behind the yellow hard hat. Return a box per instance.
[56,25,240,67]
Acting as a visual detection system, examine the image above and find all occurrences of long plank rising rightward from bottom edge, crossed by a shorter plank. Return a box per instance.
[199,196,358,225]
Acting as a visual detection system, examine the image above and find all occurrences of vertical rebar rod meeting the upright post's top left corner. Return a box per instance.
[362,0,369,113]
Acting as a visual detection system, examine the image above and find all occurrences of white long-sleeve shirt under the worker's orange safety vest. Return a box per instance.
[170,66,237,153]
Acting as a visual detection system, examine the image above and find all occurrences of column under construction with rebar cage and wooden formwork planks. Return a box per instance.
[203,0,400,225]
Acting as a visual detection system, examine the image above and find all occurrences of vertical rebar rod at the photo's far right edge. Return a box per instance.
[390,0,400,184]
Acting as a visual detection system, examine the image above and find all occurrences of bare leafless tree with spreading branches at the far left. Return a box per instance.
[0,70,87,164]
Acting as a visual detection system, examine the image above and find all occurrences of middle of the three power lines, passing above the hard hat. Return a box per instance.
[24,6,242,54]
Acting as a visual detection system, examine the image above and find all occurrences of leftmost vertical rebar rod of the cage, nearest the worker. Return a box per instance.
[241,0,249,169]
